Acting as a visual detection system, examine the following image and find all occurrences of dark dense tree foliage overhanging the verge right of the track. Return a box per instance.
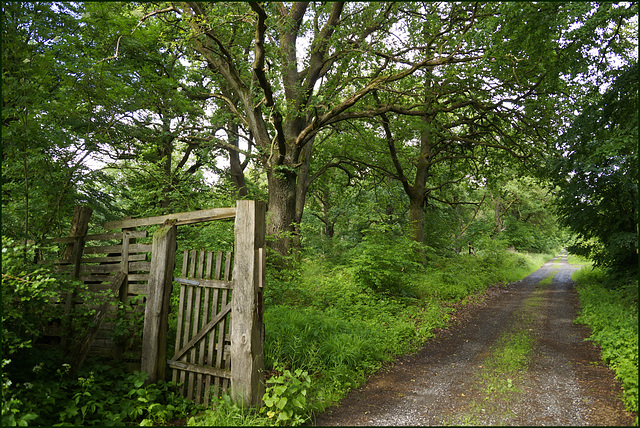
[547,62,638,269]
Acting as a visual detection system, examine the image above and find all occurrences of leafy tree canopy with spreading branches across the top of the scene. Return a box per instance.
[2,2,637,264]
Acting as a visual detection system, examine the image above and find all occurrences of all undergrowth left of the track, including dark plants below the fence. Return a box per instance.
[2,237,550,426]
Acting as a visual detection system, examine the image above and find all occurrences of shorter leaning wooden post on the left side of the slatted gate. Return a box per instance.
[140,223,177,383]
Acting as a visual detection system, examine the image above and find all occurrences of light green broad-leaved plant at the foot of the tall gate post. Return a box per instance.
[262,367,311,426]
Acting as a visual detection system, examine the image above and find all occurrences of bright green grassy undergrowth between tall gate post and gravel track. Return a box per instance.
[189,241,551,425]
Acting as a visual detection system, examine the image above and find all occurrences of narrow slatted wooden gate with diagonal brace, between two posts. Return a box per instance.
[167,250,233,406]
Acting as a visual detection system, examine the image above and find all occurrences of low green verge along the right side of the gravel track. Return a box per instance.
[573,268,638,412]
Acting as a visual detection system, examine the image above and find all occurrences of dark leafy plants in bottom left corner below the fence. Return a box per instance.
[2,360,199,426]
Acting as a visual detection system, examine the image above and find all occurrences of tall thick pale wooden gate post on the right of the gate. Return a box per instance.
[230,201,266,407]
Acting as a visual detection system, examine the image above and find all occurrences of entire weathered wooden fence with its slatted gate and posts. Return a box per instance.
[40,201,266,406]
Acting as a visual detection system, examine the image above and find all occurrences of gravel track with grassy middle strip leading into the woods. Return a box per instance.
[315,255,637,426]
